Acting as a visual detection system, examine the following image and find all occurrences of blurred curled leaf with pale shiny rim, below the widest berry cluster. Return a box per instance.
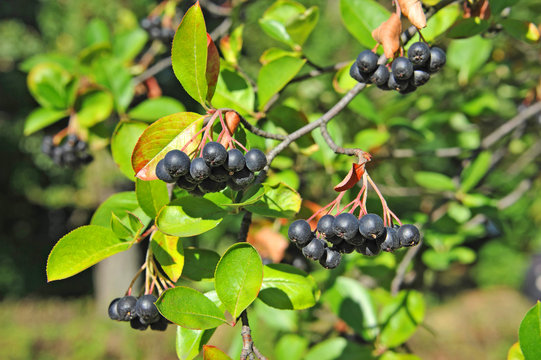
[323,276,378,341]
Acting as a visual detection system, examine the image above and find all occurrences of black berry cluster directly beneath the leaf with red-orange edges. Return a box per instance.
[156,141,267,196]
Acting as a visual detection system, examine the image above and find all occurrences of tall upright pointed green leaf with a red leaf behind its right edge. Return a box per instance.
[171,2,208,106]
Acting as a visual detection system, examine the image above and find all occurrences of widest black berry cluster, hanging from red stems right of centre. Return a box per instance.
[287,213,421,269]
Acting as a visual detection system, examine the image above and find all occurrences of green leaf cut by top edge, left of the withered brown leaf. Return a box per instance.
[340,0,391,48]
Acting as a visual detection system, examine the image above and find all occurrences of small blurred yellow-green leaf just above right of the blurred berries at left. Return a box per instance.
[76,91,113,128]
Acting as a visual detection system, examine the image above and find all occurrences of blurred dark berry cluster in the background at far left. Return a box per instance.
[41,134,94,168]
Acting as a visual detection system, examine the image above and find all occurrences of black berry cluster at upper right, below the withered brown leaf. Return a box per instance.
[349,42,446,94]
